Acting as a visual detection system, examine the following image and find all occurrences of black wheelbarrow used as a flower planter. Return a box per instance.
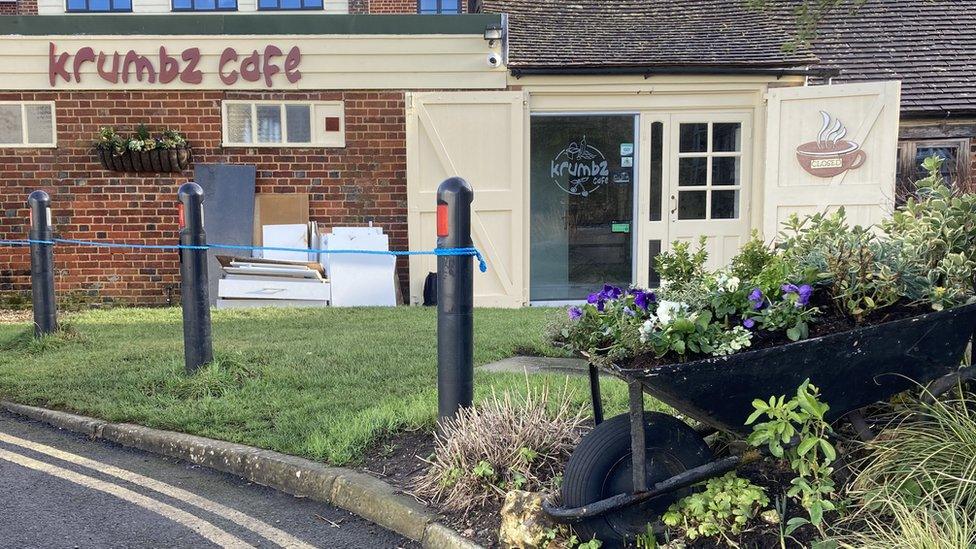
[545,304,976,547]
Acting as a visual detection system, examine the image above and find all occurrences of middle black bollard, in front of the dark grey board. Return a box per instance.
[178,182,213,374]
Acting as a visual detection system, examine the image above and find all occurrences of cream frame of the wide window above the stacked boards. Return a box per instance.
[220,99,346,149]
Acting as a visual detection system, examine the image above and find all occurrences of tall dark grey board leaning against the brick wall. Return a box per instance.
[193,164,255,305]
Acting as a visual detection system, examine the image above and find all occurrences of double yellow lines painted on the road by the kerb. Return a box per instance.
[0,433,314,549]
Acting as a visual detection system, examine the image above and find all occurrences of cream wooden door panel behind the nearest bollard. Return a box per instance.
[407,92,527,307]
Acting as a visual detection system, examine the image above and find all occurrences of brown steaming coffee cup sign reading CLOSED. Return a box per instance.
[796,111,867,177]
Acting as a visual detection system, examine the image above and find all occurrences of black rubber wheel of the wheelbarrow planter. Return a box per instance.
[562,412,712,548]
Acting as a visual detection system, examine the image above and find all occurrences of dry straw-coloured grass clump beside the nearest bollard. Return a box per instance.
[414,384,586,512]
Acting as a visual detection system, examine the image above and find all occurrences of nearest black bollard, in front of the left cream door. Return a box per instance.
[437,177,474,418]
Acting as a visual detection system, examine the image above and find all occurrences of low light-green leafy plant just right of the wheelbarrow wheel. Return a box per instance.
[661,473,769,540]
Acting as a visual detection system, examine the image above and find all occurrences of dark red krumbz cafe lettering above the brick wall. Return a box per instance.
[47,42,302,88]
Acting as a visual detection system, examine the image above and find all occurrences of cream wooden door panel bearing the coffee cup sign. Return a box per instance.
[763,82,901,239]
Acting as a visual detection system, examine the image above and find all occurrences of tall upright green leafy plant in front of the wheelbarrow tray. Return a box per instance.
[746,379,837,528]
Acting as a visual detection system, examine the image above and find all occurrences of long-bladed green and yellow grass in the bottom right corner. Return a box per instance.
[833,393,976,549]
